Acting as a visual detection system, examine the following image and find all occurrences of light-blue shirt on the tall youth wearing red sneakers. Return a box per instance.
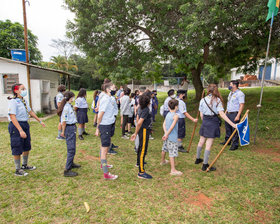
[99,94,116,125]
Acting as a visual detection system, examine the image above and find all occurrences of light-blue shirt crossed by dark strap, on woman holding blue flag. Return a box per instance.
[199,94,224,116]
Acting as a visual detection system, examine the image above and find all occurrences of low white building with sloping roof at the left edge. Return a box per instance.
[0,57,74,117]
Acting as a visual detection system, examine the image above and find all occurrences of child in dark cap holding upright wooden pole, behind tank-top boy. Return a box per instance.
[177,90,197,153]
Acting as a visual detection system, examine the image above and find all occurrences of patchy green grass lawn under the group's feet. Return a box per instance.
[0,87,280,223]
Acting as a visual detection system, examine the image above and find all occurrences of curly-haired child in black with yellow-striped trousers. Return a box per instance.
[131,93,153,179]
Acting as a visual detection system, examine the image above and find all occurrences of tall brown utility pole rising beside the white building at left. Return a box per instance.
[22,0,32,109]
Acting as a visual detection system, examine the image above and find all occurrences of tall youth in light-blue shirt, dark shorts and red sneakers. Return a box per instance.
[95,83,118,180]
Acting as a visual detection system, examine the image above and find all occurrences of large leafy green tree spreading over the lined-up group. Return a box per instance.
[65,0,279,99]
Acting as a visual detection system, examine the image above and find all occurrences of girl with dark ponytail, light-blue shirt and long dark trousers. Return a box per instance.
[57,91,81,177]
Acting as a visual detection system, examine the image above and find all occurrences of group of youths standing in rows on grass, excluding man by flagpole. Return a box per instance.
[6,79,243,180]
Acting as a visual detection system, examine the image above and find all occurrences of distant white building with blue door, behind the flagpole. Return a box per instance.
[231,58,280,81]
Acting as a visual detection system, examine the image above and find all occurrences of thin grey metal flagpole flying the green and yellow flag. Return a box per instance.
[254,12,274,144]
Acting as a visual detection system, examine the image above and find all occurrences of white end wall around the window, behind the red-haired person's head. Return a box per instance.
[0,60,27,117]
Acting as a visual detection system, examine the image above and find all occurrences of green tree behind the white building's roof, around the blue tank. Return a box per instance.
[0,20,42,64]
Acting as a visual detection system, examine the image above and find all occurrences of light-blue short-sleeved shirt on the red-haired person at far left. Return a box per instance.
[8,98,31,121]
